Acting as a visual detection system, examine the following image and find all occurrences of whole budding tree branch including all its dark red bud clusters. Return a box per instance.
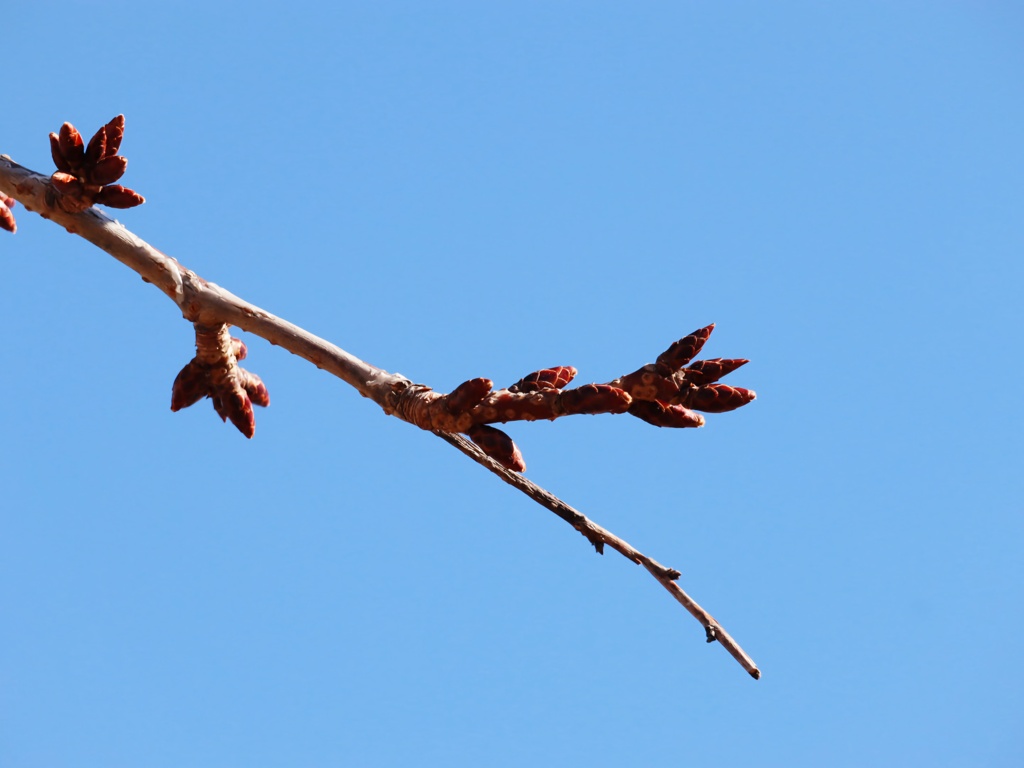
[0,143,761,679]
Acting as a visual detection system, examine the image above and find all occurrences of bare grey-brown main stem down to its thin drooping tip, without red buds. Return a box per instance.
[0,155,761,679]
